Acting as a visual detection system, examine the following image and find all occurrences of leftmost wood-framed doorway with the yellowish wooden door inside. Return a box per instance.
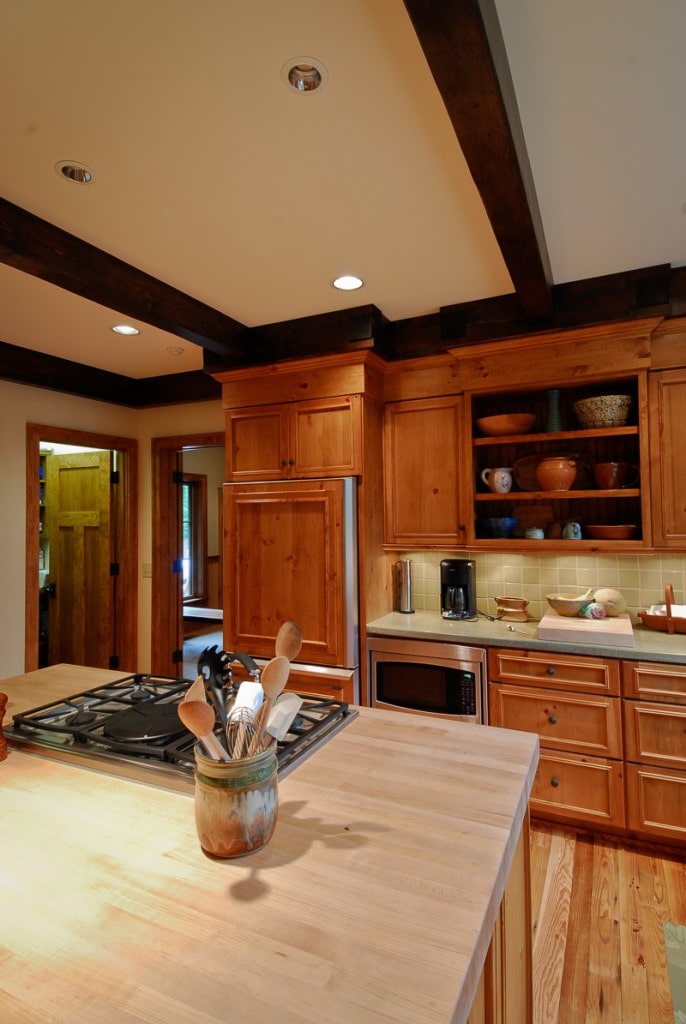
[25,423,138,672]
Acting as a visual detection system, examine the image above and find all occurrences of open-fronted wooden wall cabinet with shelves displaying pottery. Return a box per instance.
[451,319,660,552]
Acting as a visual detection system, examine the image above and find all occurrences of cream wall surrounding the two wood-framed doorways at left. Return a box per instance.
[0,381,224,679]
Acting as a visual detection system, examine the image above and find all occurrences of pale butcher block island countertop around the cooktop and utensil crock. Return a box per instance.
[0,666,538,1024]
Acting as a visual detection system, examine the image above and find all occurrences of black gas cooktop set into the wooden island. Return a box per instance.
[4,674,357,788]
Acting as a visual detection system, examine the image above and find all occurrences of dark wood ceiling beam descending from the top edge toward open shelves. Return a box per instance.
[404,0,552,323]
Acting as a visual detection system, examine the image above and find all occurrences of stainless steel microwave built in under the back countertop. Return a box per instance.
[367,637,488,725]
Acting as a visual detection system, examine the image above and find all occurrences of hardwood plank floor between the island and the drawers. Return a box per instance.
[522,820,686,1024]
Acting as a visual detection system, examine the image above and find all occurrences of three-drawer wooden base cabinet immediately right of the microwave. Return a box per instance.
[488,648,625,830]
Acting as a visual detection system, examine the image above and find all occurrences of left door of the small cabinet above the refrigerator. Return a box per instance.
[226,406,293,481]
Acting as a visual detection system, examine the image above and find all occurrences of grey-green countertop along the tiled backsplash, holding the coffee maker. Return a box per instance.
[367,611,686,665]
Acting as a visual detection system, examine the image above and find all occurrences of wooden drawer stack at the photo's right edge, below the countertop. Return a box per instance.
[623,662,686,844]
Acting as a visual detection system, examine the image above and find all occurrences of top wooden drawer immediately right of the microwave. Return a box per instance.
[488,647,619,695]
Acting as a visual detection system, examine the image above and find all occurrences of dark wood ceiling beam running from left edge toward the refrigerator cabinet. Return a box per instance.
[0,198,249,366]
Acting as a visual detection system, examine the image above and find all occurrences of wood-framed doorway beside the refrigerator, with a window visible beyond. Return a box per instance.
[151,433,225,676]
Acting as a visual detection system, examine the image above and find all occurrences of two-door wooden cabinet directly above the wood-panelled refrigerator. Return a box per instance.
[225,395,362,482]
